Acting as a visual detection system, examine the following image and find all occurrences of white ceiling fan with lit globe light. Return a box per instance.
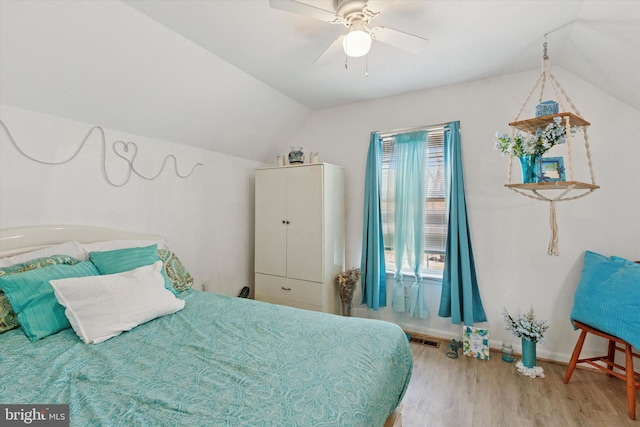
[269,0,429,66]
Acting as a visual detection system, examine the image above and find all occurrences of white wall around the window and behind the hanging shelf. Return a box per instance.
[282,67,640,361]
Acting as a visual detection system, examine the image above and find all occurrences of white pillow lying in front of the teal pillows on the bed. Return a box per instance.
[49,261,184,344]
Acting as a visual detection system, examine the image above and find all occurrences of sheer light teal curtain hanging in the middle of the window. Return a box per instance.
[392,131,428,318]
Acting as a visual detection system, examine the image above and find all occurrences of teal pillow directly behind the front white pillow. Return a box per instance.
[89,245,177,295]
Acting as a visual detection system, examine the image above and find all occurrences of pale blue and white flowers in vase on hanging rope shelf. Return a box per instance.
[494,117,581,157]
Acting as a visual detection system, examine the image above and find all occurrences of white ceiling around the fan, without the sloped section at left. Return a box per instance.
[125,0,640,109]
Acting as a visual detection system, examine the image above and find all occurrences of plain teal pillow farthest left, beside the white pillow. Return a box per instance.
[0,261,100,341]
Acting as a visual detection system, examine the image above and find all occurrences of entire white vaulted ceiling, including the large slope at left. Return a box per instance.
[0,0,640,161]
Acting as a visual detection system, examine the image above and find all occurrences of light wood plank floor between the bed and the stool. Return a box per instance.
[402,342,640,427]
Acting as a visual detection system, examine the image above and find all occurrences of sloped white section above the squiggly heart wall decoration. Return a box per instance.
[0,0,309,164]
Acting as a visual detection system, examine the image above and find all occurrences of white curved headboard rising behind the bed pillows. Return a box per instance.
[0,225,164,258]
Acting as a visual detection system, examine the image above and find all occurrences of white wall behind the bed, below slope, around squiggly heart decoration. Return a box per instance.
[0,105,261,295]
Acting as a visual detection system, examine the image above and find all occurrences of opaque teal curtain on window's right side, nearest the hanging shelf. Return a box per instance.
[438,122,487,326]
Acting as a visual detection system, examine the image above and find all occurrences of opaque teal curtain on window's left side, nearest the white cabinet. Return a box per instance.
[360,132,387,310]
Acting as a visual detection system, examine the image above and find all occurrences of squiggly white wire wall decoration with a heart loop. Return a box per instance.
[0,120,203,187]
